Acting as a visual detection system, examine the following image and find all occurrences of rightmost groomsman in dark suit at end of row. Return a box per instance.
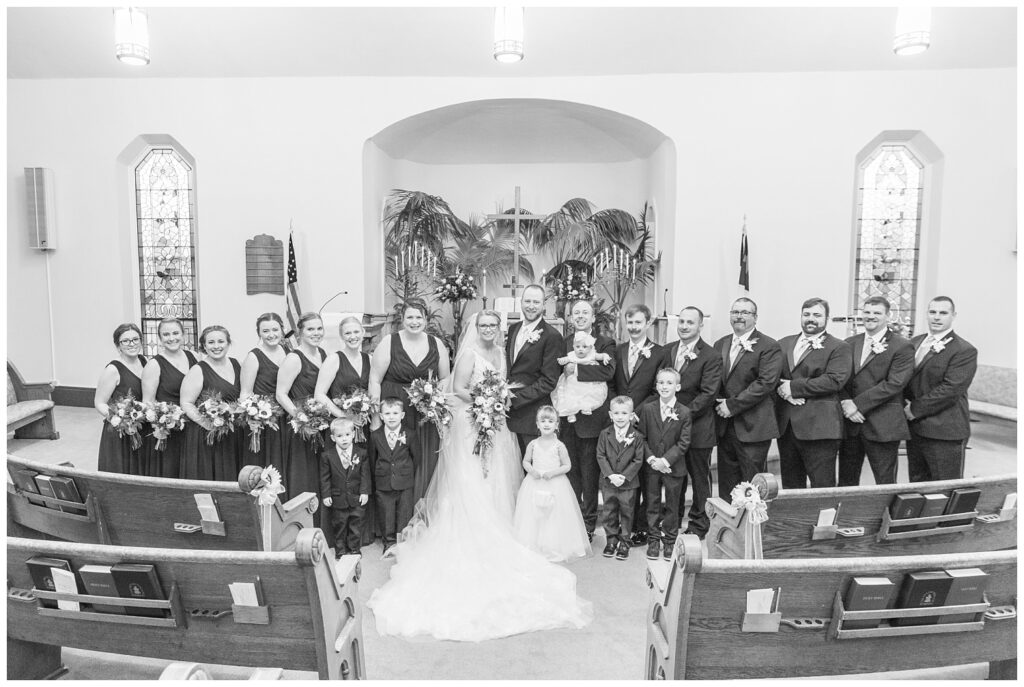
[903,296,978,482]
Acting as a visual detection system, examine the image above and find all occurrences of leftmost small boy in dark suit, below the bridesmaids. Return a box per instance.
[321,418,370,558]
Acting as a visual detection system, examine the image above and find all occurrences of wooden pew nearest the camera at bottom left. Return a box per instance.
[7,528,366,680]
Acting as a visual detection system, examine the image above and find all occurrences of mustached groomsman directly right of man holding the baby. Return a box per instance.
[609,303,659,546]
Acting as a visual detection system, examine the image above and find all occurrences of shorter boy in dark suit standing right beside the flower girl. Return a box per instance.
[597,396,644,561]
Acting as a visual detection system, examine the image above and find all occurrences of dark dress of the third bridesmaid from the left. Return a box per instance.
[181,358,245,482]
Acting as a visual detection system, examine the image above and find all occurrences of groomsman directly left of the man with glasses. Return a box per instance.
[665,305,722,539]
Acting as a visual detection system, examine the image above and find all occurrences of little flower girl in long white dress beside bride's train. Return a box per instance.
[512,405,591,562]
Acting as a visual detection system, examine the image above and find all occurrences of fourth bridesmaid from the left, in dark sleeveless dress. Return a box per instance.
[236,312,288,475]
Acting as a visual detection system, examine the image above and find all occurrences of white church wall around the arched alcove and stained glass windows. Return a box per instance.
[7,70,1017,386]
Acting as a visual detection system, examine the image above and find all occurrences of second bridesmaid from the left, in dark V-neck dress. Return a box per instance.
[142,317,197,478]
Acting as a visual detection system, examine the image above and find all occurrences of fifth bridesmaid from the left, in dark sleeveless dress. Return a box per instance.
[276,312,327,516]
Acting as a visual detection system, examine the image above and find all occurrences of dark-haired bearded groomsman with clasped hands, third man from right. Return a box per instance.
[775,298,853,489]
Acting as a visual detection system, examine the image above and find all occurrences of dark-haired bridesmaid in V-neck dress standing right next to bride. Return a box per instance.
[370,298,451,502]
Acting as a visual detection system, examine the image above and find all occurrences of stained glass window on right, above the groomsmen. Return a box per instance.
[853,144,924,336]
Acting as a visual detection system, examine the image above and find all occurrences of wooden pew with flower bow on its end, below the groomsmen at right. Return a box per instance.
[707,473,1017,558]
